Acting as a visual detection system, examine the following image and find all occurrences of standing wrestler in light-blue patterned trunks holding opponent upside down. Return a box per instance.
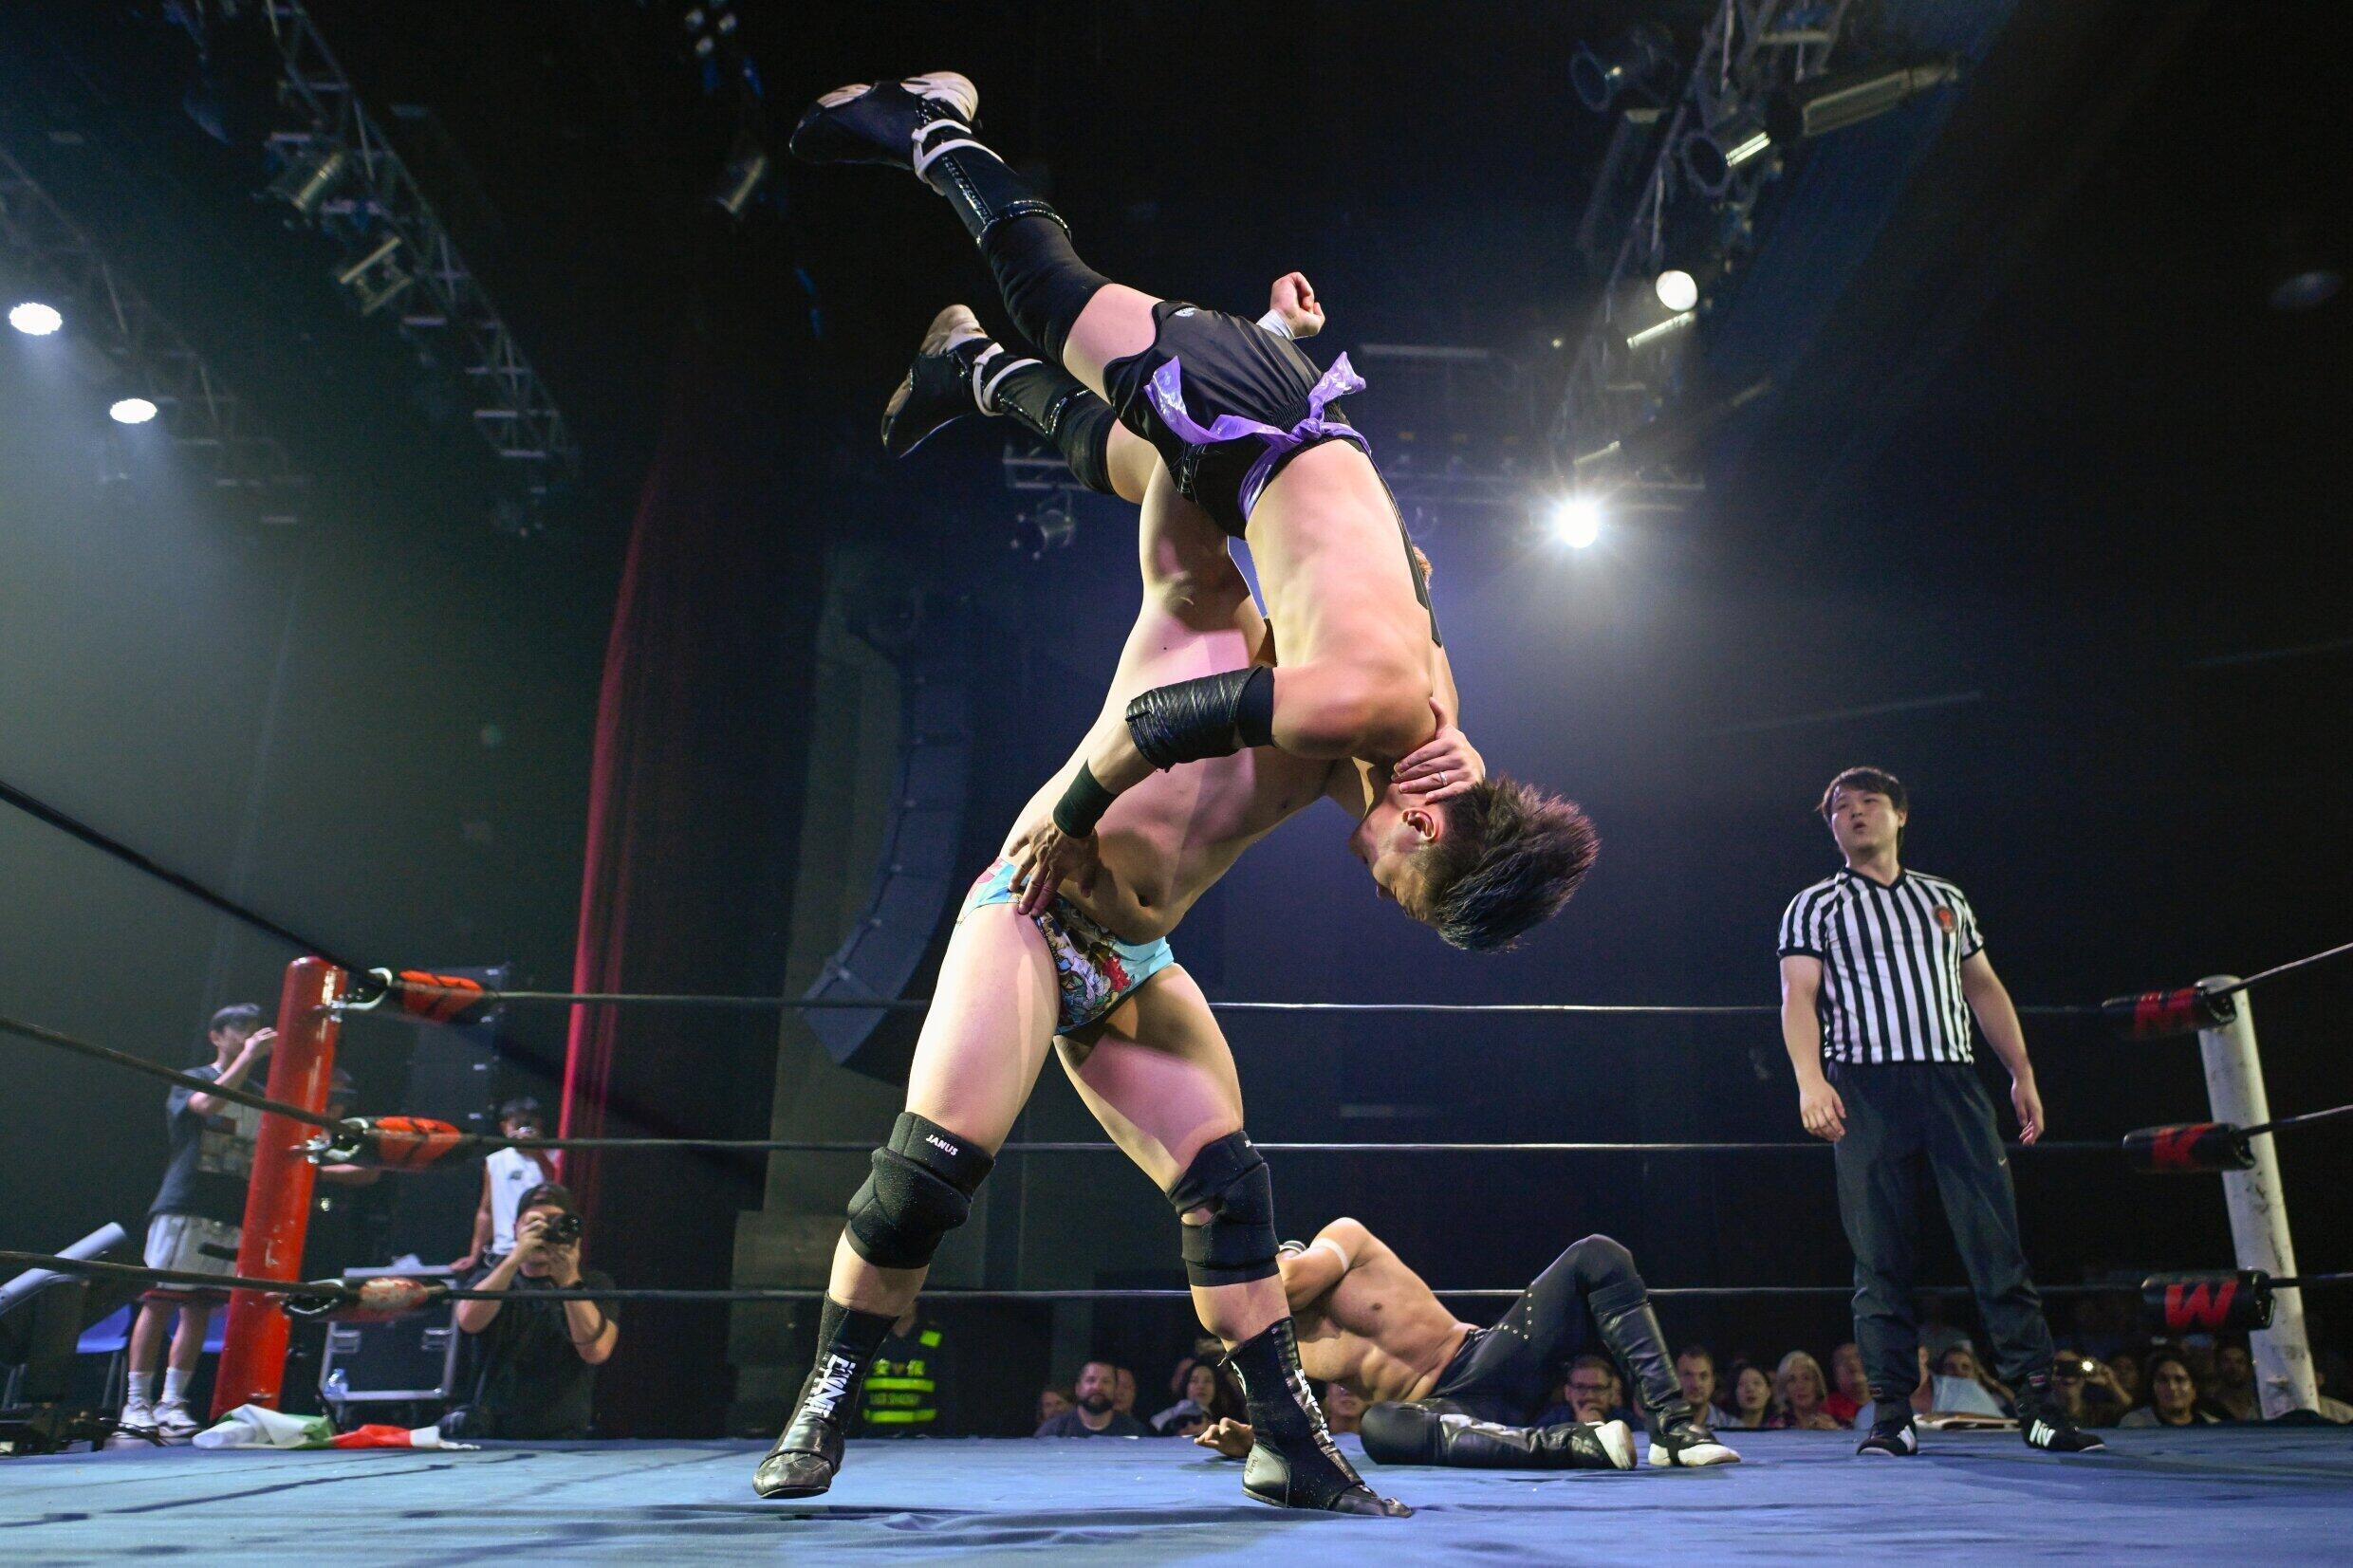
[755,310,1593,1514]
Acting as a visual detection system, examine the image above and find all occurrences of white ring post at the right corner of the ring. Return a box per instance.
[2197,975,2320,1420]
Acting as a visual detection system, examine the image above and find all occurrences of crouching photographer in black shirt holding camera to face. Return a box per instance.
[456,1183,621,1439]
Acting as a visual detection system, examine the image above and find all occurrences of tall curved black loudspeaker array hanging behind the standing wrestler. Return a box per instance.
[805,604,972,1081]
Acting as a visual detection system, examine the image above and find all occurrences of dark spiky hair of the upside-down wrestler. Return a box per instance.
[1421,773,1600,952]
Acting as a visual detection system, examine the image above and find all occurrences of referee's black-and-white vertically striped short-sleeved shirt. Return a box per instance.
[1781,867,1986,1062]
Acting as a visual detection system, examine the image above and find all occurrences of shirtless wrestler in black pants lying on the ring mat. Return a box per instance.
[1193,1220,1741,1469]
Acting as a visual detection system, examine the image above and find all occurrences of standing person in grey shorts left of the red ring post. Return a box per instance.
[120,1002,278,1441]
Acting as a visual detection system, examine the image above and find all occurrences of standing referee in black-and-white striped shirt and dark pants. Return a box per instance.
[1781,768,2103,1455]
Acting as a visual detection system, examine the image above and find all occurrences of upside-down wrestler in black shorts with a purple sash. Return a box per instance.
[793,73,1558,945]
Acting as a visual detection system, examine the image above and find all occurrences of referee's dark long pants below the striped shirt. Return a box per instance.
[1828,1062,2052,1401]
